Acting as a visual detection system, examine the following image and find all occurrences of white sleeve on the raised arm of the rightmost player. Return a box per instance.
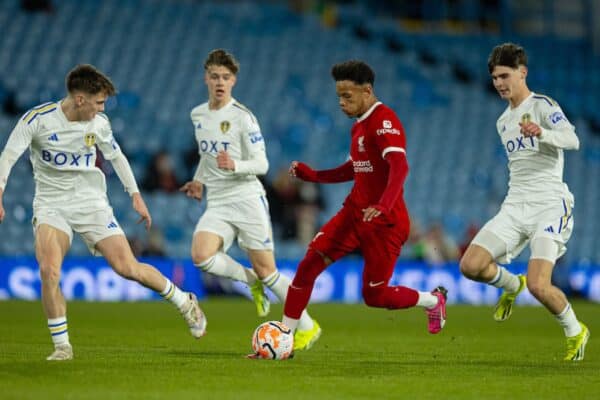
[539,102,579,150]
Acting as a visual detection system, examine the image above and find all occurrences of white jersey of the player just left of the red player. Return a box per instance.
[191,99,268,203]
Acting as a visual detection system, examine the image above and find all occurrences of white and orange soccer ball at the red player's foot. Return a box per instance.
[252,321,294,360]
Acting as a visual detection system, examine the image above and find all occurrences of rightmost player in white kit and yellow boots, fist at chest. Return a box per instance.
[460,43,590,361]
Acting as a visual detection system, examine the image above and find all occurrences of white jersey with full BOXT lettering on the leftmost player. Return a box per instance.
[6,102,121,208]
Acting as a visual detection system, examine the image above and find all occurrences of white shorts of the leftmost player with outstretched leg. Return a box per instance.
[32,205,125,256]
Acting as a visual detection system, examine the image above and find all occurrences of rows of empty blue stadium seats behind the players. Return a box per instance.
[0,0,600,263]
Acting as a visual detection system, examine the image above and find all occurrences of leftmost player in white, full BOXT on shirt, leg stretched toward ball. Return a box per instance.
[0,64,206,360]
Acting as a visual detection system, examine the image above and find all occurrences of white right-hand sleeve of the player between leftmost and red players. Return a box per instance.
[234,113,269,175]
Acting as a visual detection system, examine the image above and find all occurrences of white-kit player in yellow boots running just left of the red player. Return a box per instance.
[181,49,321,350]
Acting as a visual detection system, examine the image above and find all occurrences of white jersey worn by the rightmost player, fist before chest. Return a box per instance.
[496,93,579,202]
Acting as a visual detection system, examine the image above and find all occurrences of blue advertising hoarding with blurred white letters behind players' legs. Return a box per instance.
[0,257,600,304]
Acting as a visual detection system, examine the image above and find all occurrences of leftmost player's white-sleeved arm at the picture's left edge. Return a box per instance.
[0,119,37,222]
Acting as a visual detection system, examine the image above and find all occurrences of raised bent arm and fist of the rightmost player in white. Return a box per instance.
[519,104,579,150]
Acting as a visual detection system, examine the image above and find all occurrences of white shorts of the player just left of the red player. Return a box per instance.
[194,196,274,252]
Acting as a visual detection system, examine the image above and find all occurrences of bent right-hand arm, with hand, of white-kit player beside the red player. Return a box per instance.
[217,115,269,175]
